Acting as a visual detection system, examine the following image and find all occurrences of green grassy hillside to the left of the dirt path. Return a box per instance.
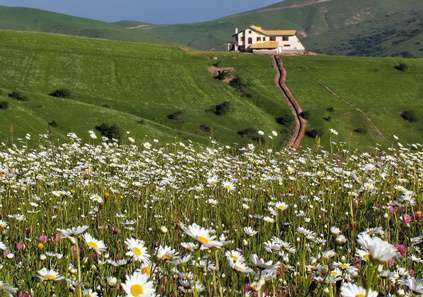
[0,31,290,146]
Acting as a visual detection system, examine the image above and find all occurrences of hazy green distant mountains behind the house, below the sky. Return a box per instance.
[0,0,423,57]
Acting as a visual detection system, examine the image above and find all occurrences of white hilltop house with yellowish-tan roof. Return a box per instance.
[228,26,305,54]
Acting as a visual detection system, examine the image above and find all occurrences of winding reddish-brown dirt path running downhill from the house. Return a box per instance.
[273,56,307,149]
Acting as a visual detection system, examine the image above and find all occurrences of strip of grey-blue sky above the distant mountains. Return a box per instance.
[0,0,281,24]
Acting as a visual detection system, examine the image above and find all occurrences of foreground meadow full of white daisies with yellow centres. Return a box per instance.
[0,130,423,297]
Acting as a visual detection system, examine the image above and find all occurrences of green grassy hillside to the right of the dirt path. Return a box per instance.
[285,56,423,147]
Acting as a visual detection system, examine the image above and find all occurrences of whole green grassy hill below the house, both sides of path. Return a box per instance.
[0,31,423,148]
